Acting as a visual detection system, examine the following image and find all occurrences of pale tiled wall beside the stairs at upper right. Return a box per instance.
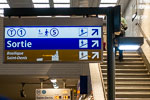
[124,0,150,66]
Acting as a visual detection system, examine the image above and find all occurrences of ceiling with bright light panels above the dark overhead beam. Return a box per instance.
[0,0,130,17]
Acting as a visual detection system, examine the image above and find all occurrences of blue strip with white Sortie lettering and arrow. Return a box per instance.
[5,38,101,50]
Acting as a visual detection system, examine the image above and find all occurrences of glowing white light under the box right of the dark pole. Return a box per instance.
[119,45,140,50]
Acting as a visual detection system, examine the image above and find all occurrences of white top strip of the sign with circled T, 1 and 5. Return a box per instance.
[5,26,101,38]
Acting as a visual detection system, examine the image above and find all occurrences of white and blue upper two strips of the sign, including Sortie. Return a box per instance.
[5,26,101,50]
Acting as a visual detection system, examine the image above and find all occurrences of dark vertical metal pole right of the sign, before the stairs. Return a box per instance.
[107,7,115,100]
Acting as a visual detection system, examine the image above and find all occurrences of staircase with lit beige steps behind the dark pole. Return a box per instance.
[101,52,150,100]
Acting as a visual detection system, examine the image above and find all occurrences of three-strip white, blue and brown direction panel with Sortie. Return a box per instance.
[4,26,102,63]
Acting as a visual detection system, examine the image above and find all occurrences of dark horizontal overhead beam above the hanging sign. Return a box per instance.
[4,7,107,16]
